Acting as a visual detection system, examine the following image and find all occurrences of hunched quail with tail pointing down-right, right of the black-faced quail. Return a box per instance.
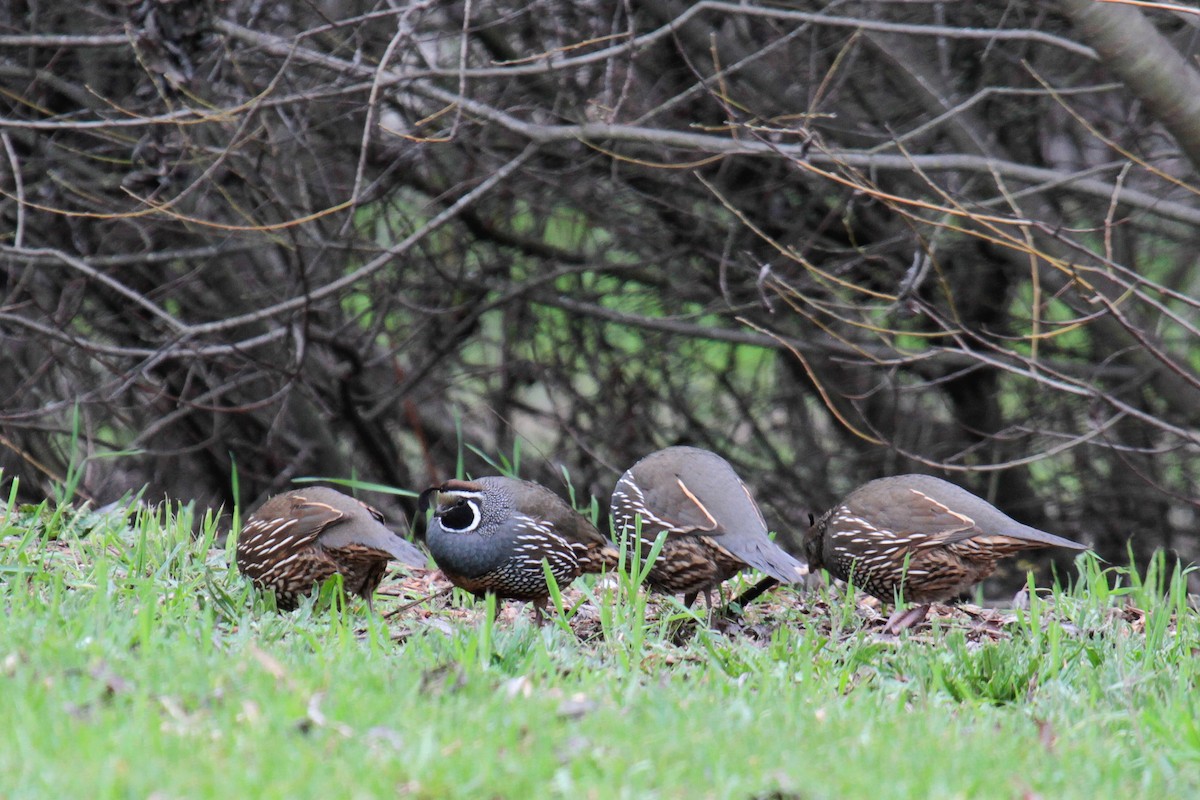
[612,447,808,608]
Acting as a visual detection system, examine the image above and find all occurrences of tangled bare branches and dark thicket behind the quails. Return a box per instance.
[0,0,1200,587]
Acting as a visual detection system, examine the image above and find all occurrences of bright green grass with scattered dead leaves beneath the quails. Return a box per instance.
[0,496,1200,799]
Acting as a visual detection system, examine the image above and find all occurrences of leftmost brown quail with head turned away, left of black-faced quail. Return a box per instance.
[236,486,426,610]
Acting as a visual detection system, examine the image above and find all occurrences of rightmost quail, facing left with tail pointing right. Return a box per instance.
[804,475,1087,632]
